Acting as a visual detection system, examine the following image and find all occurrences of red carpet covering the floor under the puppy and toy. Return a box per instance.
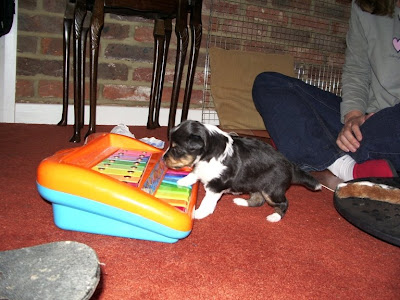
[0,123,400,300]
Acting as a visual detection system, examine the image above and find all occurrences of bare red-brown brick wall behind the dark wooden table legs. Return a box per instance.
[16,0,207,108]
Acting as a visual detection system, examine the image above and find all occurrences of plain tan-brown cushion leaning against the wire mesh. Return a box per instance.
[210,48,294,130]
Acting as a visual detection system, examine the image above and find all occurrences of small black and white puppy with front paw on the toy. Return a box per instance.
[164,121,321,222]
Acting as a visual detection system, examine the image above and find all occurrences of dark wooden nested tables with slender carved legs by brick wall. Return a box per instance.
[59,0,202,142]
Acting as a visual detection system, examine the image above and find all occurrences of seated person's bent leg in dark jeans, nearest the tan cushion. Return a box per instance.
[253,72,343,171]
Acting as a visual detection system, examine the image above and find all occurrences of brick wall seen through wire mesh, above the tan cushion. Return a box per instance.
[206,0,351,66]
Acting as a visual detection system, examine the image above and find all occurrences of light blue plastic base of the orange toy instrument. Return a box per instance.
[37,184,190,243]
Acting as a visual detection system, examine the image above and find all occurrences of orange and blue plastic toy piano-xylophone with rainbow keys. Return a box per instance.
[37,133,198,243]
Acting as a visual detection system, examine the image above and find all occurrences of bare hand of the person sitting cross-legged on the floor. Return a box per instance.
[336,110,373,152]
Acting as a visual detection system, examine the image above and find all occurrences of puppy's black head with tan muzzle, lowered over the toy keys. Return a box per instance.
[164,121,206,169]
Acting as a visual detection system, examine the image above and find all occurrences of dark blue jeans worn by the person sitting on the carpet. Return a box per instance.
[253,72,400,171]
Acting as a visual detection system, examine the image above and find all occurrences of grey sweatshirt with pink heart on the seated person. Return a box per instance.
[341,0,400,122]
